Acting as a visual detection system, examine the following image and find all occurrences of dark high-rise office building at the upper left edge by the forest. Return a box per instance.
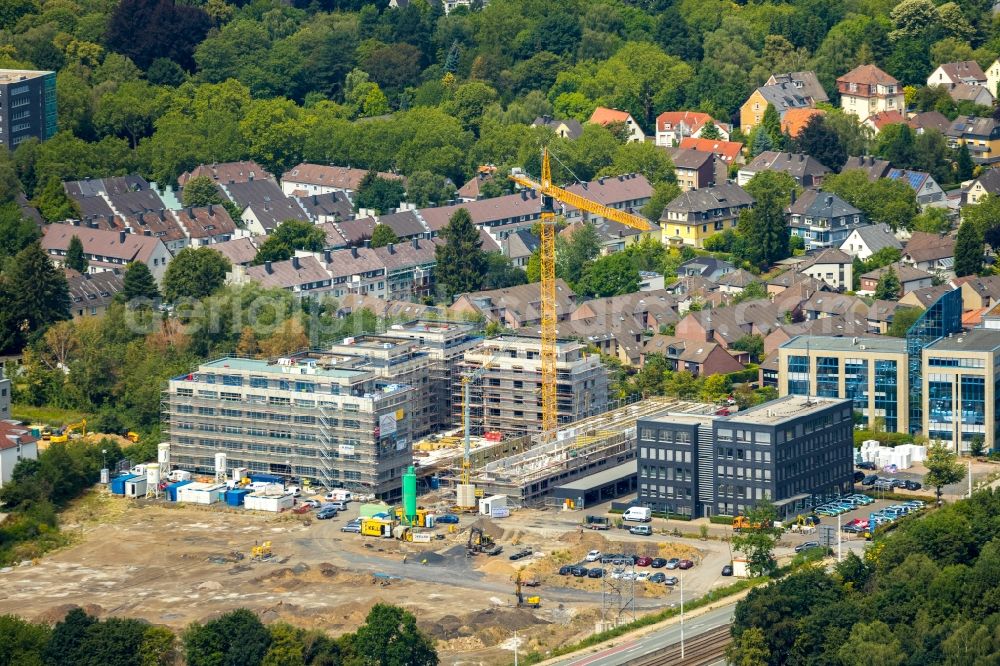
[0,69,58,150]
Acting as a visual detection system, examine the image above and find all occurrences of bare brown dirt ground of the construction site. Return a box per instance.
[0,491,728,664]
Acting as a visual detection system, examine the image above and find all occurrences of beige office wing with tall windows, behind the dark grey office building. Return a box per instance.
[778,335,910,432]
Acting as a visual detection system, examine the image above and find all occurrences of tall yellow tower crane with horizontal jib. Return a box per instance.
[510,148,655,440]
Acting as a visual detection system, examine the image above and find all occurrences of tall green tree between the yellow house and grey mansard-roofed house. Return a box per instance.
[738,171,797,268]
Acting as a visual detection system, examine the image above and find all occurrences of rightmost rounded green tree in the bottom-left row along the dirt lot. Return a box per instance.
[346,604,438,666]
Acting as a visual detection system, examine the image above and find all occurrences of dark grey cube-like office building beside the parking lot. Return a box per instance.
[638,396,854,518]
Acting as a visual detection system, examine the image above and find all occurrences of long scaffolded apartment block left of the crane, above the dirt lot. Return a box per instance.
[163,353,417,499]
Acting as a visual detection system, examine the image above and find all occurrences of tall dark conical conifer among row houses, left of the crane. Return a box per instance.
[434,208,488,301]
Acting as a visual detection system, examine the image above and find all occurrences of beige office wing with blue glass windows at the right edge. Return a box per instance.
[920,329,1000,453]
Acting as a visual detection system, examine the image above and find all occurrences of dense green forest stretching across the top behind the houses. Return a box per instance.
[0,0,1000,196]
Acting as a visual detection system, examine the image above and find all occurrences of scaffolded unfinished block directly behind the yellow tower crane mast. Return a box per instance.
[452,336,608,435]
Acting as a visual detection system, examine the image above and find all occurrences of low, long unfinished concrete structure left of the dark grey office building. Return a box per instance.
[455,398,718,504]
